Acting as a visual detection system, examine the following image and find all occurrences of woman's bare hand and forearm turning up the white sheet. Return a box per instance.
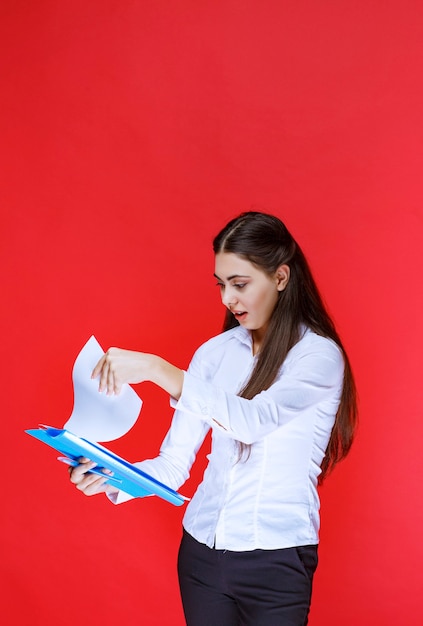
[91,348,184,399]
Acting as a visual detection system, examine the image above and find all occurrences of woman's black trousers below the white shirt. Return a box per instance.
[178,531,317,626]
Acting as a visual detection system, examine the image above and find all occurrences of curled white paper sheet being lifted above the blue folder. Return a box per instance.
[64,336,142,442]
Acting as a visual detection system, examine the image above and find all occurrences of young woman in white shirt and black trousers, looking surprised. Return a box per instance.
[70,212,356,626]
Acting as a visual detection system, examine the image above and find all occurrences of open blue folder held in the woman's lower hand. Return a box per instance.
[25,426,187,506]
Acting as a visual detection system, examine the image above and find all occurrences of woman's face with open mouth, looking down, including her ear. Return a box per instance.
[215,252,289,346]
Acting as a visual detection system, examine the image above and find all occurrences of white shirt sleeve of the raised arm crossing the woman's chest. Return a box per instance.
[176,338,344,444]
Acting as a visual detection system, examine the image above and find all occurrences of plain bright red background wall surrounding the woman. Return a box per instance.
[0,0,423,626]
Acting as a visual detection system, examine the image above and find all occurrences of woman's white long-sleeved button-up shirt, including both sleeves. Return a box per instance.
[118,326,344,551]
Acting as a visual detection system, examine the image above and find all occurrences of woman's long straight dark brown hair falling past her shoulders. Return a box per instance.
[213,211,357,482]
